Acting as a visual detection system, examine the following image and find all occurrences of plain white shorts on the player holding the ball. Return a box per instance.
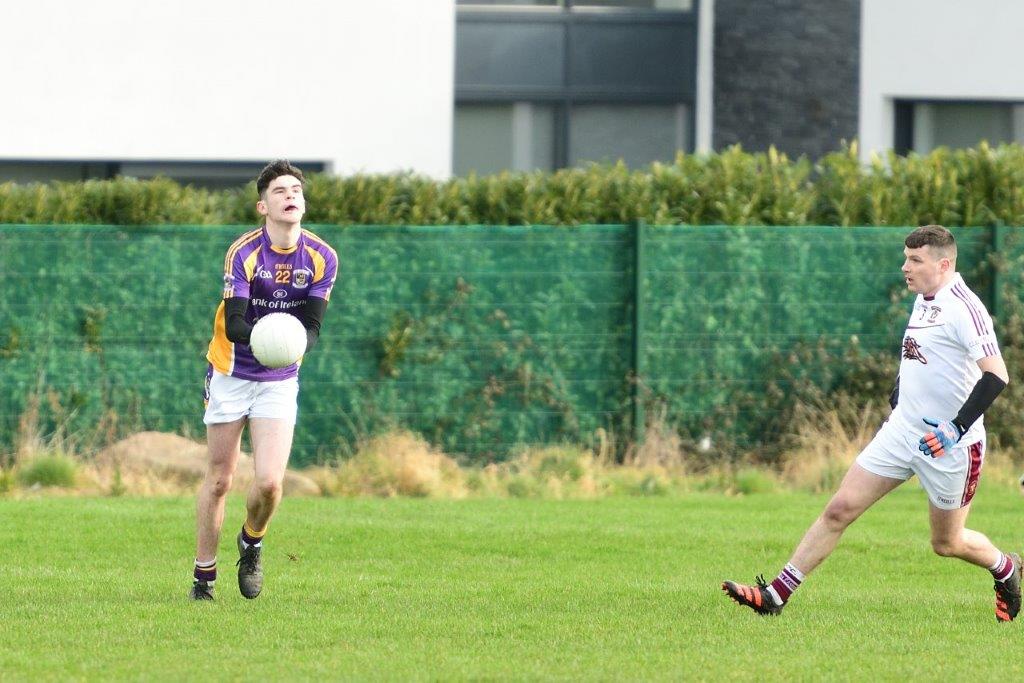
[203,371,299,425]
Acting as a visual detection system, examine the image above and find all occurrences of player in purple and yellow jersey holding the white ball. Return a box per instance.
[190,160,338,600]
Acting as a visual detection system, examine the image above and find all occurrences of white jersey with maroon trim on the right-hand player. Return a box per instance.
[890,273,999,443]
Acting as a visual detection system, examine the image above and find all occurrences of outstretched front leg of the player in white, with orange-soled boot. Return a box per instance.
[722,463,903,614]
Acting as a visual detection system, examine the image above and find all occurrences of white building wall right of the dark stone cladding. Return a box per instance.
[859,0,1024,159]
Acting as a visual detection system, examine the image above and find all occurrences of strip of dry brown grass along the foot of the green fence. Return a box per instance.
[0,399,1021,499]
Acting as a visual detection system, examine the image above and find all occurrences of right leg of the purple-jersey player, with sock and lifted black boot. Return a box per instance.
[238,418,295,598]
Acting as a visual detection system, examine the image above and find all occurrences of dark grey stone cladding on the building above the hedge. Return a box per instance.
[713,0,860,159]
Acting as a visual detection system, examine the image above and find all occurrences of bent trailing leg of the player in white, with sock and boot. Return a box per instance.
[929,504,1021,622]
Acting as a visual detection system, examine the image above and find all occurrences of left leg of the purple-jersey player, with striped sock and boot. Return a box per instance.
[193,418,246,599]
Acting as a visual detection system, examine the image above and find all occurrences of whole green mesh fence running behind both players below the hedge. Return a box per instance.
[0,225,996,464]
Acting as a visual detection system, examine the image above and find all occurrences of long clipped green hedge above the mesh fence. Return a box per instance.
[6,143,1024,226]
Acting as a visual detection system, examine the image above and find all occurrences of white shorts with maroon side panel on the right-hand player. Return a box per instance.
[857,422,985,510]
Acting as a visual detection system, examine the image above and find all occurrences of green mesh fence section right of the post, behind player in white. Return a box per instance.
[639,226,992,445]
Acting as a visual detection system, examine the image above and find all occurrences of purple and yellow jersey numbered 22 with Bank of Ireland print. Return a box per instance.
[206,227,338,382]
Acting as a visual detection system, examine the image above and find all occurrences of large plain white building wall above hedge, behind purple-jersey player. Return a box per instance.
[0,0,455,177]
